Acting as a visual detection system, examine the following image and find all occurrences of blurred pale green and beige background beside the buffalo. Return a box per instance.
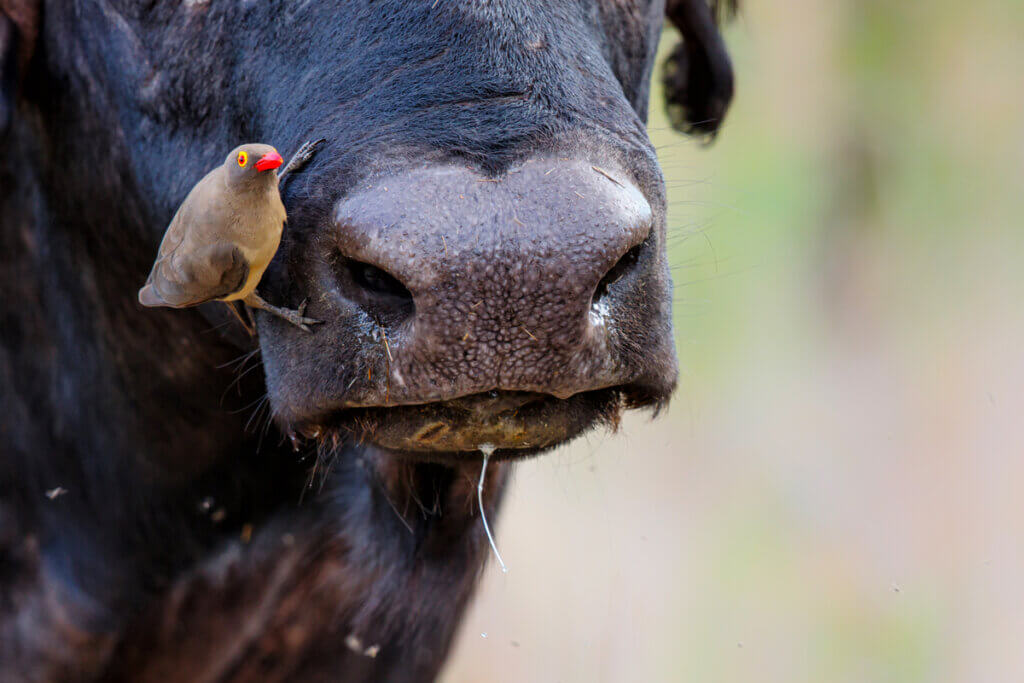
[444,0,1024,683]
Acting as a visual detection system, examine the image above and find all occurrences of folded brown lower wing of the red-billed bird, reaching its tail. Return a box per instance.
[138,242,249,308]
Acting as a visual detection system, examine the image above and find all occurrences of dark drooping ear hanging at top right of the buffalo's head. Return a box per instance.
[664,0,736,141]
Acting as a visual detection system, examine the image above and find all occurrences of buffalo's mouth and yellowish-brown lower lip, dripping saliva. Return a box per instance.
[301,387,659,462]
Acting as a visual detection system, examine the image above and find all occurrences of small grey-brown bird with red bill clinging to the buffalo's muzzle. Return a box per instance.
[138,139,324,332]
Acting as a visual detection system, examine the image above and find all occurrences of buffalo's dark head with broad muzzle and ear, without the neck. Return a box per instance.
[0,0,732,460]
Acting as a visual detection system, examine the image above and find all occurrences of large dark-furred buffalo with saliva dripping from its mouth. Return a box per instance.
[0,0,733,682]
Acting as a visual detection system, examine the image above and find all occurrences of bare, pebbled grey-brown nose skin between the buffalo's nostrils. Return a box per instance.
[328,160,652,405]
